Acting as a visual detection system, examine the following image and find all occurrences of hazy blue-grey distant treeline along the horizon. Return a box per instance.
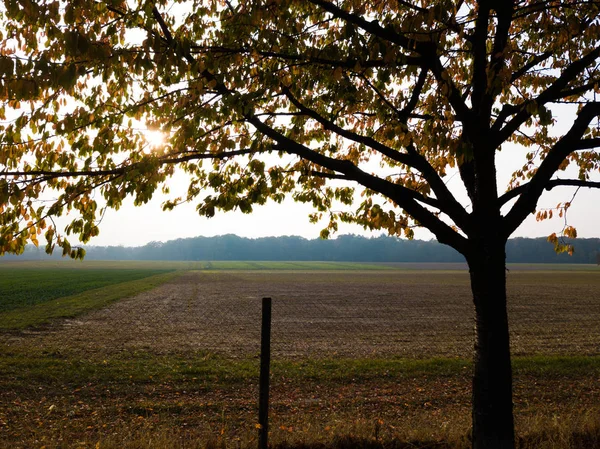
[4,234,600,263]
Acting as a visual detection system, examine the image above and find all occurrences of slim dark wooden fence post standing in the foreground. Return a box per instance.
[258,298,271,449]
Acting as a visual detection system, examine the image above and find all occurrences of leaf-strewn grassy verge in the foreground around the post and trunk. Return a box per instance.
[0,347,600,449]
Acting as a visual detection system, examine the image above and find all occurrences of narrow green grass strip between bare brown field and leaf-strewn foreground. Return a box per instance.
[0,346,600,386]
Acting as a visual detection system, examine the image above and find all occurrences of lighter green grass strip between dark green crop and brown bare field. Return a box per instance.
[0,271,183,330]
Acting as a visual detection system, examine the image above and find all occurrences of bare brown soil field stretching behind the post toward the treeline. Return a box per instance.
[6,271,600,358]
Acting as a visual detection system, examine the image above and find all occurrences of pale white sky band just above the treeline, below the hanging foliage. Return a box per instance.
[83,189,600,246]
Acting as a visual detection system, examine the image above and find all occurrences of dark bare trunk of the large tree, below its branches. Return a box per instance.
[467,240,515,449]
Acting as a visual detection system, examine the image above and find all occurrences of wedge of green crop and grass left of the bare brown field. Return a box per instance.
[0,270,182,330]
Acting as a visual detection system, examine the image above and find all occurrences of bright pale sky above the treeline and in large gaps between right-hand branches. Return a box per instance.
[78,101,600,246]
